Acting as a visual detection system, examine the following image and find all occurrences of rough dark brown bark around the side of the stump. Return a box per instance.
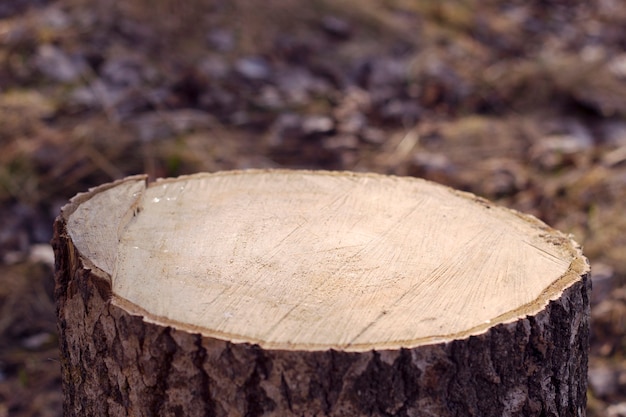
[54,171,590,417]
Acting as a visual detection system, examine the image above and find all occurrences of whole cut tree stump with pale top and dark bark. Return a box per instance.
[54,170,590,417]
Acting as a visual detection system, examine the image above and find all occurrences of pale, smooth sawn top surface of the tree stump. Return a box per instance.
[64,170,588,351]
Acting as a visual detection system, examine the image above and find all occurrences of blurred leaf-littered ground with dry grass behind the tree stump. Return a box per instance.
[0,0,626,417]
